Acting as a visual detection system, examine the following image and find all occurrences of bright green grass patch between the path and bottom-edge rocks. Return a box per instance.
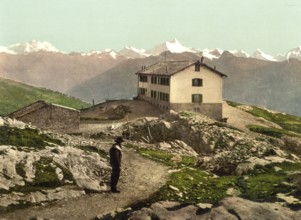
[145,162,301,205]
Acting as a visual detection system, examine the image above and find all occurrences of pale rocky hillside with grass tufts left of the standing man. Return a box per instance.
[0,118,110,211]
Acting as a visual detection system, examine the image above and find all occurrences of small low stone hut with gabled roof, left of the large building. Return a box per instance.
[9,100,80,133]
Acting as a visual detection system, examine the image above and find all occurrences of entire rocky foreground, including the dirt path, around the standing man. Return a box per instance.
[0,102,301,219]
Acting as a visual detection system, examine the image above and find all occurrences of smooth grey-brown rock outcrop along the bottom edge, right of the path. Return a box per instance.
[129,197,301,220]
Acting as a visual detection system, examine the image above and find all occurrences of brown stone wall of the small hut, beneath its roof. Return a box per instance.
[16,104,79,132]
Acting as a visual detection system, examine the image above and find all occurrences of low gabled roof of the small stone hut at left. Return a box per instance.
[8,100,79,119]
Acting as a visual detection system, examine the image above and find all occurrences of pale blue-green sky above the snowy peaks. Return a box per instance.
[0,0,301,55]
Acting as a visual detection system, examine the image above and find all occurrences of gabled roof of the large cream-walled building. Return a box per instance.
[137,61,227,77]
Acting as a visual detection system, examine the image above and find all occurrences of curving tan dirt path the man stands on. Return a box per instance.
[0,149,167,220]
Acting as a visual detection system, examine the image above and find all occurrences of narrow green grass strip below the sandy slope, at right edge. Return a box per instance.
[247,125,301,138]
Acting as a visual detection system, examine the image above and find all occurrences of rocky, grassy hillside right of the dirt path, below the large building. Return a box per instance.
[98,106,301,219]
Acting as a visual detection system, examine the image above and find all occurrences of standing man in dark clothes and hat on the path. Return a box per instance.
[110,137,124,193]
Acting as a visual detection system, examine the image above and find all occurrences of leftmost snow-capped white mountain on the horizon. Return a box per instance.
[0,40,60,54]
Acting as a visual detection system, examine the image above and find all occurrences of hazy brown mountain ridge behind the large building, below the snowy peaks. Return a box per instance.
[0,41,301,115]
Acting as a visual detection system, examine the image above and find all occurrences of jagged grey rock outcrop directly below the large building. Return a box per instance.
[120,112,299,175]
